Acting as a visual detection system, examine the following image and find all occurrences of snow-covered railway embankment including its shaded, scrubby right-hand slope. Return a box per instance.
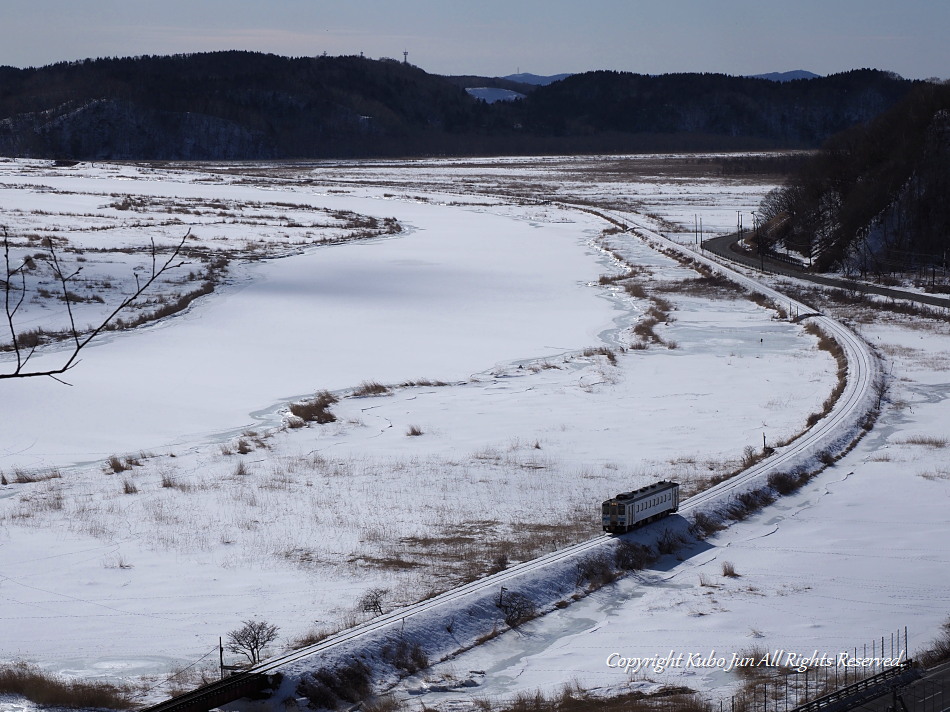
[171,206,881,707]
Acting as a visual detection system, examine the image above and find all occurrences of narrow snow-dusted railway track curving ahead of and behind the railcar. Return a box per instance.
[144,204,879,712]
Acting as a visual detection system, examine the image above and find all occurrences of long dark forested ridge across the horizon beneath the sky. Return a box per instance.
[0,52,924,159]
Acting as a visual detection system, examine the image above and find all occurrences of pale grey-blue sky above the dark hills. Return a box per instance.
[0,0,950,79]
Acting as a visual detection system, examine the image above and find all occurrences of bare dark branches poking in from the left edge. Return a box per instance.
[0,228,191,383]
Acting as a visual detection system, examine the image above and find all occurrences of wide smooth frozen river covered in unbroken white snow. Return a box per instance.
[0,195,615,469]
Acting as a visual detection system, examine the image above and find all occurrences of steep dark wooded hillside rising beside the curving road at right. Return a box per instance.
[759,84,950,274]
